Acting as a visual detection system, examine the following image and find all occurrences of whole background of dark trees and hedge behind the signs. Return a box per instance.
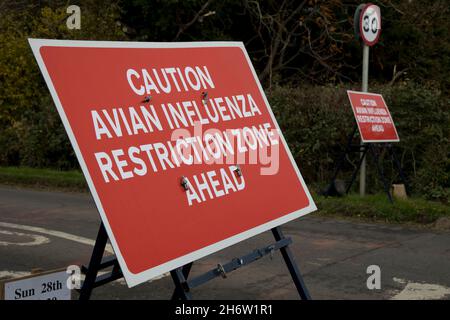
[0,0,450,201]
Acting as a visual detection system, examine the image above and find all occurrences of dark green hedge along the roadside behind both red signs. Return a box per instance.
[0,84,450,202]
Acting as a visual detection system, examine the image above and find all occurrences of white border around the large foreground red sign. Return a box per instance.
[28,39,317,287]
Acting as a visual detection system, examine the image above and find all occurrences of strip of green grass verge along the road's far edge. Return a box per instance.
[0,167,450,224]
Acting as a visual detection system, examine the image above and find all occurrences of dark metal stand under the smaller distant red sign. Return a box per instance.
[322,125,409,203]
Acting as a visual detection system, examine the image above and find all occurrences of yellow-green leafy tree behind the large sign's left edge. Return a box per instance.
[0,0,125,168]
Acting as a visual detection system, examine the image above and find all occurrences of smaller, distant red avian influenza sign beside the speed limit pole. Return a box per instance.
[347,90,400,143]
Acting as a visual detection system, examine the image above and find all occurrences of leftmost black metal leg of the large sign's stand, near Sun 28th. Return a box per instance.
[79,223,108,300]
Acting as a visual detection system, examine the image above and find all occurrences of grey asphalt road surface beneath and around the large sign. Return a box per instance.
[0,186,450,299]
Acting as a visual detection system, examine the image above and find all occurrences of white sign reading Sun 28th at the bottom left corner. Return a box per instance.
[4,271,71,300]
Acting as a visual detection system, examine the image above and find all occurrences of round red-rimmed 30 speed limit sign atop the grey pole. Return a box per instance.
[359,3,381,46]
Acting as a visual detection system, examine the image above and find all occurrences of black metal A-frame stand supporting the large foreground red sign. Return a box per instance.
[79,223,311,300]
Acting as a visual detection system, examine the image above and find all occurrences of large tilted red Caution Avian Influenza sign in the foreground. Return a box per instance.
[30,39,316,286]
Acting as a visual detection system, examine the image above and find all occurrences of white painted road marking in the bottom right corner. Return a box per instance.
[391,278,450,300]
